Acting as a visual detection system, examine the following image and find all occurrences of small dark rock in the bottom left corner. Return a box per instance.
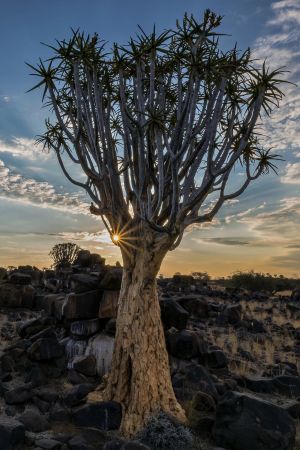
[0,415,25,450]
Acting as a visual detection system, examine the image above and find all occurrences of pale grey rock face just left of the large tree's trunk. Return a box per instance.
[85,334,115,376]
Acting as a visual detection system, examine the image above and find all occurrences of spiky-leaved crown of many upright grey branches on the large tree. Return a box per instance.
[30,10,283,248]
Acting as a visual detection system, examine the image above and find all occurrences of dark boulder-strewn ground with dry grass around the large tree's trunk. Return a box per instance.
[0,254,300,450]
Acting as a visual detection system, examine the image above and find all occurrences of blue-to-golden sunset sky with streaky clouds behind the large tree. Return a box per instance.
[0,0,300,276]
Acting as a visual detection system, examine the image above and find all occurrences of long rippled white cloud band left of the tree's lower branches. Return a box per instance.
[0,160,90,214]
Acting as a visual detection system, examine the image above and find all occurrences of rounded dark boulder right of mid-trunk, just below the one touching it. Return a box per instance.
[167,330,205,359]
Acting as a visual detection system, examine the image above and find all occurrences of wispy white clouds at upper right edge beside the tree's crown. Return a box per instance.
[254,0,300,150]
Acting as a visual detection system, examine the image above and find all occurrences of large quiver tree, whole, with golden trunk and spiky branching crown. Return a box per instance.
[31,11,282,434]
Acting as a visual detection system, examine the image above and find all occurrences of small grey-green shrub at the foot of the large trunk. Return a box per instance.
[137,412,194,450]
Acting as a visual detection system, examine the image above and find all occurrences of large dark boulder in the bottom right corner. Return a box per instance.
[213,391,296,450]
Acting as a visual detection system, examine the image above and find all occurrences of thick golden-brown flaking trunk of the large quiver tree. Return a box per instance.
[105,225,185,436]
